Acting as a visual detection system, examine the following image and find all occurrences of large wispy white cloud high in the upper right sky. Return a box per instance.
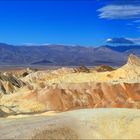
[97,5,140,19]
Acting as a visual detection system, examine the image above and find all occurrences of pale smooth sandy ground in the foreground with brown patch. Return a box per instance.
[0,109,140,139]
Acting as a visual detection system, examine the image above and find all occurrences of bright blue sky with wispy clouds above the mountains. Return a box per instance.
[0,0,140,46]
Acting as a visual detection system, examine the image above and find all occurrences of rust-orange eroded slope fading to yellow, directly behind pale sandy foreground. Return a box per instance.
[1,83,140,112]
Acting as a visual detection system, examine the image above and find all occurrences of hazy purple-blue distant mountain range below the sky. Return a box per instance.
[0,43,140,66]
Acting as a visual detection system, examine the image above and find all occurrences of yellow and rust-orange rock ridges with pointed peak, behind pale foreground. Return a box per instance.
[0,55,140,113]
